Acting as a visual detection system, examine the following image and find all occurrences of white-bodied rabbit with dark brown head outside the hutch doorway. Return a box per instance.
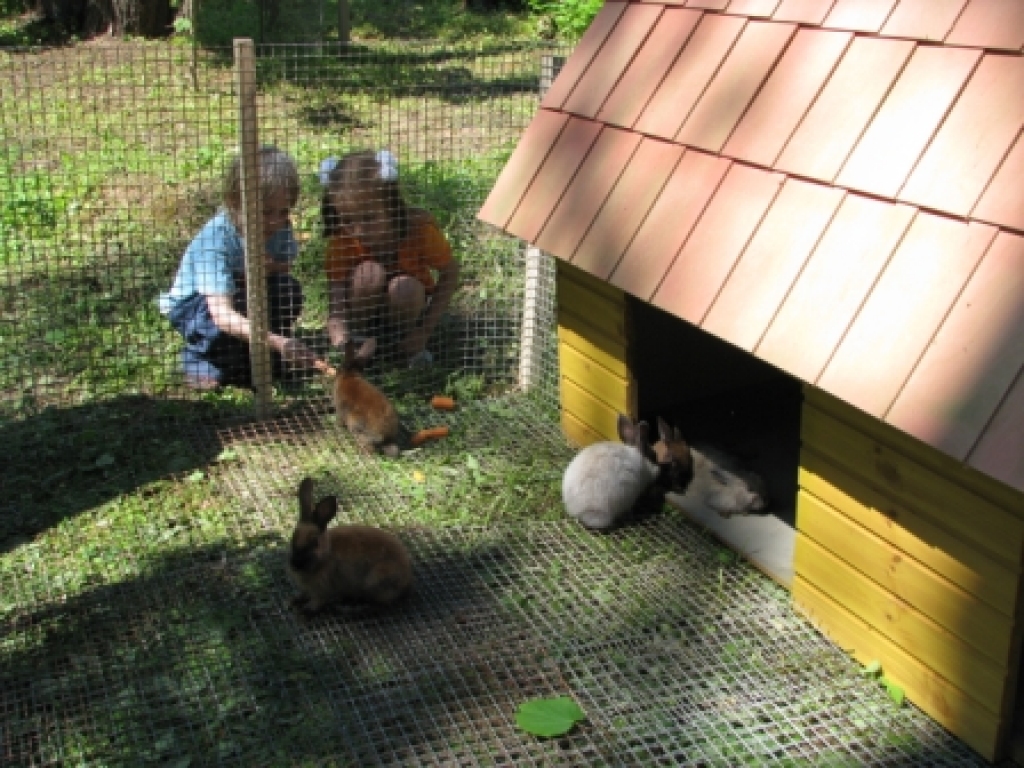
[562,414,692,530]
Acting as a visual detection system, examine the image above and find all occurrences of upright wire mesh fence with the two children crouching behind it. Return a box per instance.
[0,39,553,423]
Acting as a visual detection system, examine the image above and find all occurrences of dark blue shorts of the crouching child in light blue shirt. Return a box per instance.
[167,274,302,389]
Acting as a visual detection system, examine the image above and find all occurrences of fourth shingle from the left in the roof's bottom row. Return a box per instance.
[572,139,684,280]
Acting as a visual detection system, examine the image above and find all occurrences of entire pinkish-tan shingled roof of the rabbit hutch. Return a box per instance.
[479,0,1024,490]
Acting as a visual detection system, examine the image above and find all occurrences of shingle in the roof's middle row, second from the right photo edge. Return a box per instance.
[899,54,1024,216]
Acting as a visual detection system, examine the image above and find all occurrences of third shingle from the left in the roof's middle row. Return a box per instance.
[597,8,700,128]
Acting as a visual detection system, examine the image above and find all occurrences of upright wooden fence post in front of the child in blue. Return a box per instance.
[234,38,272,419]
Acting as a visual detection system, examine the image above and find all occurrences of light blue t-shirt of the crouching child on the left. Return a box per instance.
[160,211,299,314]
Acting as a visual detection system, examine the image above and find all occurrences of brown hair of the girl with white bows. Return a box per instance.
[321,150,410,240]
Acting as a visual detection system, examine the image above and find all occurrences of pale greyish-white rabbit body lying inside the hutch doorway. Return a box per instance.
[679,443,767,517]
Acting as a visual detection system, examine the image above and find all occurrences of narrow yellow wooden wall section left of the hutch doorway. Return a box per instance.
[557,261,636,446]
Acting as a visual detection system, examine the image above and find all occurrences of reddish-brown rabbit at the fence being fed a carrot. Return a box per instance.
[334,341,447,457]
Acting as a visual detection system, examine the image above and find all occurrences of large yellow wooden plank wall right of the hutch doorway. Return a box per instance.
[793,386,1024,760]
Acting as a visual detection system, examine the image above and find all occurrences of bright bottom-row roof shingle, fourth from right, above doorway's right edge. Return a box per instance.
[754,195,915,382]
